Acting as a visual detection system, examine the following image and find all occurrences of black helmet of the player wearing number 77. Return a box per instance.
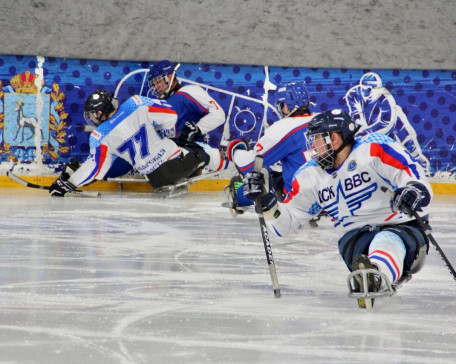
[84,89,118,125]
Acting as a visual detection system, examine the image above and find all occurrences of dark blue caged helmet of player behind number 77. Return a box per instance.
[148,59,180,99]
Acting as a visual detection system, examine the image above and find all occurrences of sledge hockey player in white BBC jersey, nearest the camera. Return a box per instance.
[244,109,433,309]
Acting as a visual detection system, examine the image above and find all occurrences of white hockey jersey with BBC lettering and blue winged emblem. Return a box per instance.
[269,133,432,236]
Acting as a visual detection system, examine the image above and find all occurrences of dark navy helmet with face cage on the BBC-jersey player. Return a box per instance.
[306,109,359,169]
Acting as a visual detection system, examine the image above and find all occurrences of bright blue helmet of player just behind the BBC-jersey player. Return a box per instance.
[274,82,309,117]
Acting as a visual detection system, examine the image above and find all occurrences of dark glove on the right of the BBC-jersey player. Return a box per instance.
[390,183,431,216]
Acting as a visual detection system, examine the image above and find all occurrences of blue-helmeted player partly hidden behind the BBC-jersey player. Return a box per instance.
[224,82,315,216]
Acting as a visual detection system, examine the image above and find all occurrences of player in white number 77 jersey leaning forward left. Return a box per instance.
[49,90,209,196]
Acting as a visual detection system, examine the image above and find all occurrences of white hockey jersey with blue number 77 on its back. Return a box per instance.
[70,96,181,186]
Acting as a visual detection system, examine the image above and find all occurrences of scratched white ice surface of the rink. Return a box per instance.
[0,189,456,364]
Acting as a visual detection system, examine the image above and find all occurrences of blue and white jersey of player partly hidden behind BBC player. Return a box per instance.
[233,114,315,193]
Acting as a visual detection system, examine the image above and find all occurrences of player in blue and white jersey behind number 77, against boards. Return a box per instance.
[148,60,225,149]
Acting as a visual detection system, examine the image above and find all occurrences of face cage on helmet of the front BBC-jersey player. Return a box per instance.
[304,131,336,169]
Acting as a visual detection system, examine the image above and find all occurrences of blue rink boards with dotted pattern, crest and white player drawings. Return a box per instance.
[0,56,456,182]
